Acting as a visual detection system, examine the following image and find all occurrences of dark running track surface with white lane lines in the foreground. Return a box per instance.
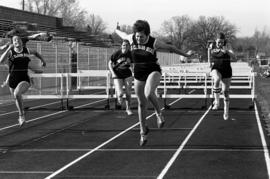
[0,95,270,179]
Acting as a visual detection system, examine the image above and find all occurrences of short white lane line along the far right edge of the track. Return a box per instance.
[254,102,270,179]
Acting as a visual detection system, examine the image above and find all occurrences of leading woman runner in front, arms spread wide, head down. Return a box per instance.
[115,20,195,146]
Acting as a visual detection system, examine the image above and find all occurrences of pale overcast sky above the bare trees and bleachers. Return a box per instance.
[0,0,270,37]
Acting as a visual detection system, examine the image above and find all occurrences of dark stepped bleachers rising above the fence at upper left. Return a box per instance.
[0,6,112,47]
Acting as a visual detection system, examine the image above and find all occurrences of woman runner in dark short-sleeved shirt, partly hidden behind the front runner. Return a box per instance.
[108,40,133,115]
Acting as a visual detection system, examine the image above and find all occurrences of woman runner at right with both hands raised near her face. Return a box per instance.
[208,33,235,120]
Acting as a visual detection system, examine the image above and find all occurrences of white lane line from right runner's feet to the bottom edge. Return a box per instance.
[157,106,211,179]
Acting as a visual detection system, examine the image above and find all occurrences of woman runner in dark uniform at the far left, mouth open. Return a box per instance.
[0,36,44,126]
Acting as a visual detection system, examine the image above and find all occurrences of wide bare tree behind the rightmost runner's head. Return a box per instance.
[158,15,237,60]
